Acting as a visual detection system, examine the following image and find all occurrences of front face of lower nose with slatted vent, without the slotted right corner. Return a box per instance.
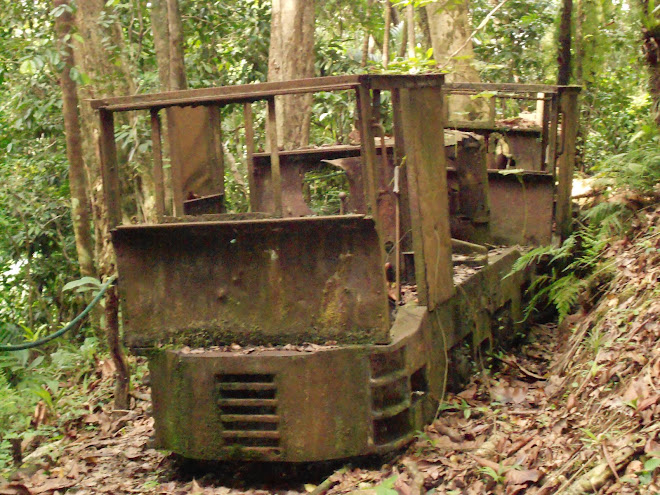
[150,348,370,462]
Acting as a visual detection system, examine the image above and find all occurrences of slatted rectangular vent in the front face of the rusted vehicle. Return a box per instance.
[216,374,280,451]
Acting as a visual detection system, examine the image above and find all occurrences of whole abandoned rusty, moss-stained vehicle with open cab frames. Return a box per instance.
[92,75,574,462]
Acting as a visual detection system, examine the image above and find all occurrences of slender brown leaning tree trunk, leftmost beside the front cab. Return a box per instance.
[54,0,96,277]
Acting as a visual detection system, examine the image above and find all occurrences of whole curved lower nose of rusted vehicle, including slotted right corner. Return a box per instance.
[150,307,442,462]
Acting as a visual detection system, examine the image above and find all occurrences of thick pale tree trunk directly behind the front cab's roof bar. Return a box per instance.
[268,0,314,149]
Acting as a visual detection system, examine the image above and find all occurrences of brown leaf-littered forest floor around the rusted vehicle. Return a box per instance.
[0,208,660,495]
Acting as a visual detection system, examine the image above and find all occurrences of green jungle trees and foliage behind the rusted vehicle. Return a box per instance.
[0,0,660,493]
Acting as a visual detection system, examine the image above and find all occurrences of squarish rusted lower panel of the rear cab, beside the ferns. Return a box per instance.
[488,171,554,246]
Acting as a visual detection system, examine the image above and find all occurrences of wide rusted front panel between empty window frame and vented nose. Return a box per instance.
[113,215,389,347]
